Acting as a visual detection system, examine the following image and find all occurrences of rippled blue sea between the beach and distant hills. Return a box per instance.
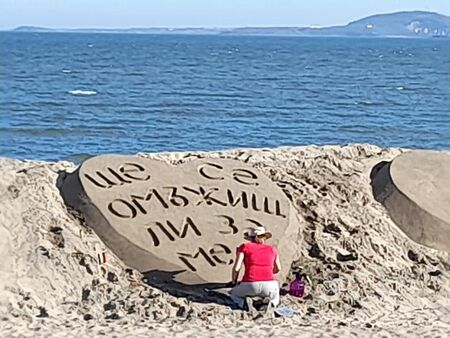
[0,32,450,162]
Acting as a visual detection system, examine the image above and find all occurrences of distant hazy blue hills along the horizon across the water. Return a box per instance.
[9,11,450,37]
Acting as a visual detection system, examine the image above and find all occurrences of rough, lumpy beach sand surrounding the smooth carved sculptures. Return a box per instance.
[0,145,450,337]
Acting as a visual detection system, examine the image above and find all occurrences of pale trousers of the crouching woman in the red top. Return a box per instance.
[230,280,280,308]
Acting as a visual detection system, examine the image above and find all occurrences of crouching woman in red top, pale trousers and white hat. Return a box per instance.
[230,227,281,308]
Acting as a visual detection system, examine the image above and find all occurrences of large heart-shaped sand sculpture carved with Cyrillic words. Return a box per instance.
[61,155,300,284]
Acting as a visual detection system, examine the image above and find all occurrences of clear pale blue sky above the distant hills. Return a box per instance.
[0,0,450,29]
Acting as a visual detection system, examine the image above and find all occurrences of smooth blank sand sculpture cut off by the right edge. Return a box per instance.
[374,151,450,252]
